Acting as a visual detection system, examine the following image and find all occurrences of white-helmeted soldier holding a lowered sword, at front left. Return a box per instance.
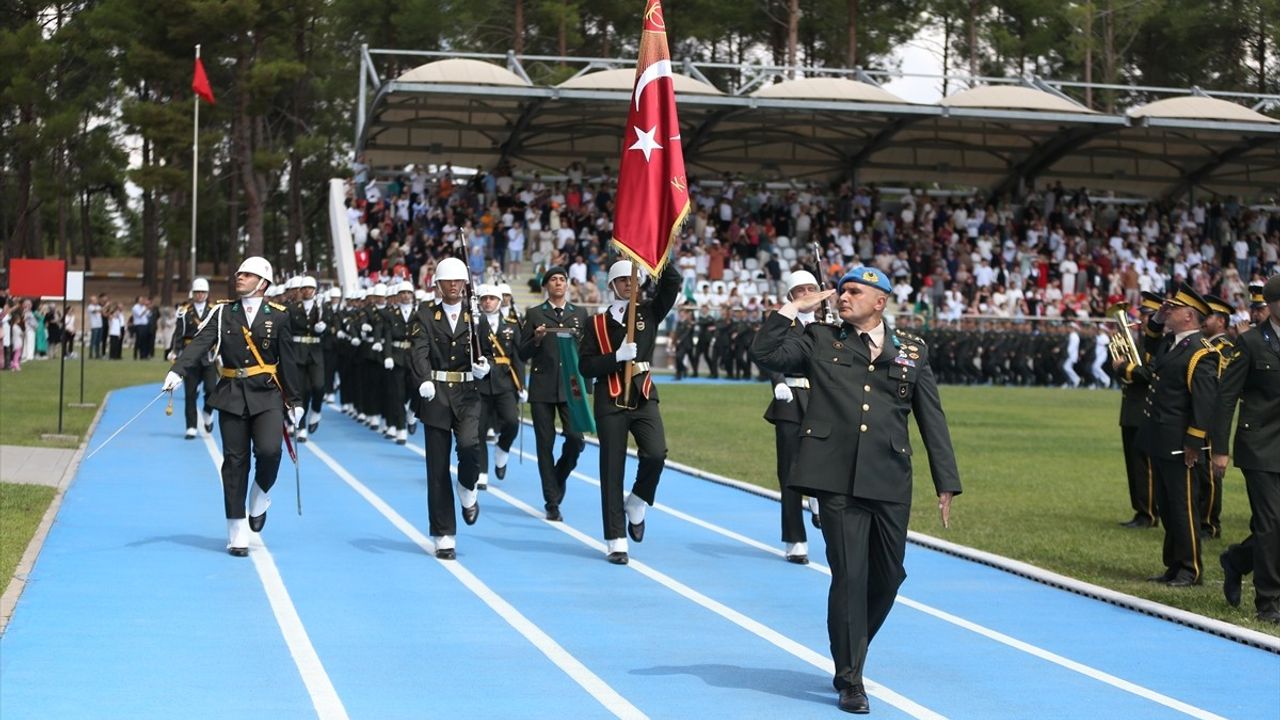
[164,256,303,557]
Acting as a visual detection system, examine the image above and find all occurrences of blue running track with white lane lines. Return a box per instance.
[0,387,1280,720]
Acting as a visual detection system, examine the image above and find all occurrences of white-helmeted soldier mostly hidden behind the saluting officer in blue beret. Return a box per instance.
[764,270,820,565]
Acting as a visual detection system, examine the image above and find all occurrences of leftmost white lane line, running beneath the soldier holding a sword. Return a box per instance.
[200,430,347,720]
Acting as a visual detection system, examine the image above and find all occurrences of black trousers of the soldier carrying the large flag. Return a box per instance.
[595,397,667,539]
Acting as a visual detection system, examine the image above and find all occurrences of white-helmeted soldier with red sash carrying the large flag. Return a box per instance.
[581,260,682,565]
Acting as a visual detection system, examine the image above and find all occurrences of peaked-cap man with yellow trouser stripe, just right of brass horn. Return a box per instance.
[1138,283,1217,588]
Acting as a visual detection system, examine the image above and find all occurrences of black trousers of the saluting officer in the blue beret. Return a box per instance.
[818,492,911,691]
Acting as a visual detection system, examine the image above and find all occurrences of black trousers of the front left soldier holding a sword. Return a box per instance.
[218,406,284,520]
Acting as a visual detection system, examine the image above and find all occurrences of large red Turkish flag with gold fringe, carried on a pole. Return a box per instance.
[613,0,689,278]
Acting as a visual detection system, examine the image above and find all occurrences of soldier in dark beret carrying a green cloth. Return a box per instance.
[520,265,586,521]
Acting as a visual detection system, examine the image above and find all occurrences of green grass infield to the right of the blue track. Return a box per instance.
[662,382,1280,635]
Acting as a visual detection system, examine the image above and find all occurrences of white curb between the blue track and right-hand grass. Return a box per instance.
[550,420,1280,655]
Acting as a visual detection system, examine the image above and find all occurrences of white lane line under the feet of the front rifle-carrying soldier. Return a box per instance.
[303,439,648,720]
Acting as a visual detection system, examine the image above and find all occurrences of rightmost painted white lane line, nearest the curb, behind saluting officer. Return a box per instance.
[532,450,1225,720]
